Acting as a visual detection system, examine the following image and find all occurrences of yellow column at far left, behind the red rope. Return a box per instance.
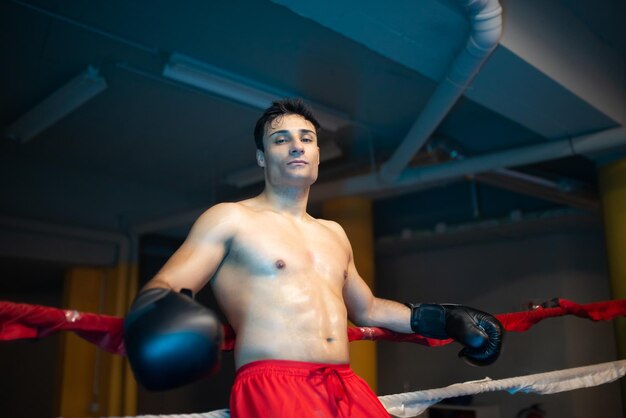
[59,265,137,417]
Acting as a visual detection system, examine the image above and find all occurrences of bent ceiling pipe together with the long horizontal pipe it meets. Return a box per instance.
[310,0,626,202]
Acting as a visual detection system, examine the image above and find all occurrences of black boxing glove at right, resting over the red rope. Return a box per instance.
[407,303,504,366]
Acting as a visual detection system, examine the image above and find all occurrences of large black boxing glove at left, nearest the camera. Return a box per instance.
[124,288,224,390]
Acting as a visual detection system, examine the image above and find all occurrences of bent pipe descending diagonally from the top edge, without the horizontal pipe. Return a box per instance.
[379,0,502,183]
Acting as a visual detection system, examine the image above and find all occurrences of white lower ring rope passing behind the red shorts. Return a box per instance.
[105,360,626,418]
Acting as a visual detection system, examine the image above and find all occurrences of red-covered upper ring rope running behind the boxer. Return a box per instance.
[0,299,626,355]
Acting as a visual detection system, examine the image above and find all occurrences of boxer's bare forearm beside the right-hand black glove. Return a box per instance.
[353,298,413,333]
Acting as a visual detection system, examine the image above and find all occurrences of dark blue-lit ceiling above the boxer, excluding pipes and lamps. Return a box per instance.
[0,0,626,262]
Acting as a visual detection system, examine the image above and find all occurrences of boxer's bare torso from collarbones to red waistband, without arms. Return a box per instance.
[211,201,350,367]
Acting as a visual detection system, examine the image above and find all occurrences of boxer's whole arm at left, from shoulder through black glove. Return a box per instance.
[124,204,238,390]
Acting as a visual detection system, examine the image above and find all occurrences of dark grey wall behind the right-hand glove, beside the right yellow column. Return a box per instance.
[377,230,622,418]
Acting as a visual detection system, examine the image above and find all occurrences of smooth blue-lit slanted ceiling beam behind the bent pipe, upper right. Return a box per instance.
[273,0,626,138]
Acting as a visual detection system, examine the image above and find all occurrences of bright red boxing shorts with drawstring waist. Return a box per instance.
[230,360,390,418]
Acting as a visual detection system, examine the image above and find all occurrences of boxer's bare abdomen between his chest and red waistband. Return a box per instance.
[212,268,349,368]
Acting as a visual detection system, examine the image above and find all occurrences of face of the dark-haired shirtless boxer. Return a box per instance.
[257,115,319,186]
